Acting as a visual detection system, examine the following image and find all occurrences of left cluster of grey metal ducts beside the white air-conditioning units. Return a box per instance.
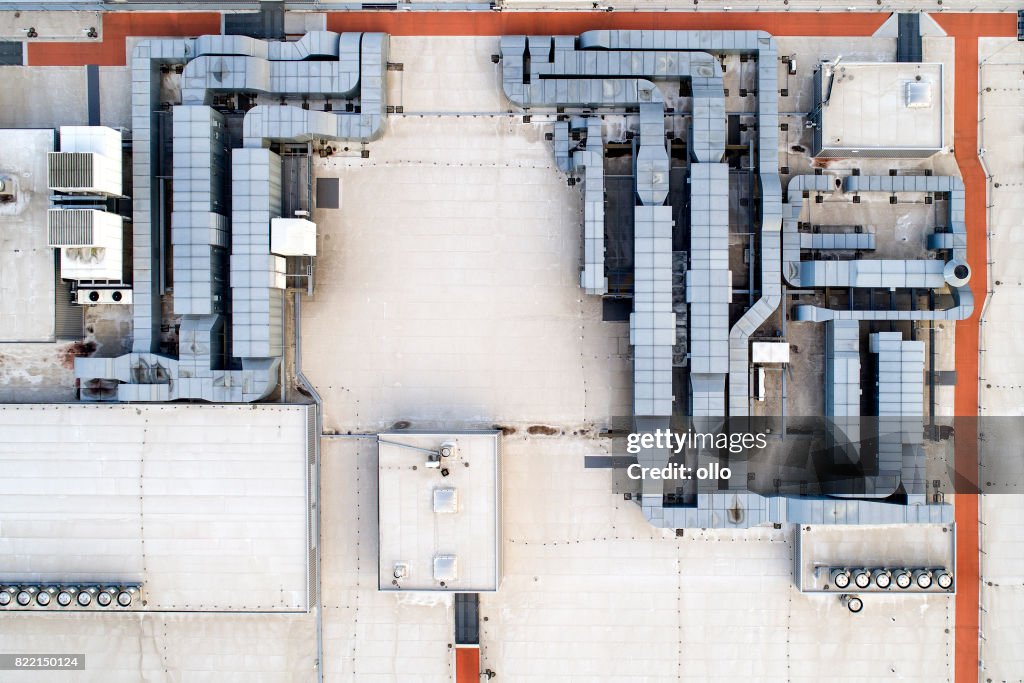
[75,32,388,402]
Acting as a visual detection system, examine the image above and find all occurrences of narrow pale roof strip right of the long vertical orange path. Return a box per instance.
[978,38,1024,681]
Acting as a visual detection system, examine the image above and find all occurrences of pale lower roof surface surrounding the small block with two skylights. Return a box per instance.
[323,431,952,683]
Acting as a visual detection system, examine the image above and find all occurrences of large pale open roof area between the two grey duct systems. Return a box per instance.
[302,38,631,431]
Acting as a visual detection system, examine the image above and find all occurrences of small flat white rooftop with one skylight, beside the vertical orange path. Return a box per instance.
[820,61,943,154]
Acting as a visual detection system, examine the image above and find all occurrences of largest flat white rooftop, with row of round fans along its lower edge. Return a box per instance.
[0,403,311,611]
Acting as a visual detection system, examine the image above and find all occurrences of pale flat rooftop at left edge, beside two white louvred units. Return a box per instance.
[0,129,55,342]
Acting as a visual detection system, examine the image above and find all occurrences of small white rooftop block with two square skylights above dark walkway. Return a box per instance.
[377,431,502,593]
